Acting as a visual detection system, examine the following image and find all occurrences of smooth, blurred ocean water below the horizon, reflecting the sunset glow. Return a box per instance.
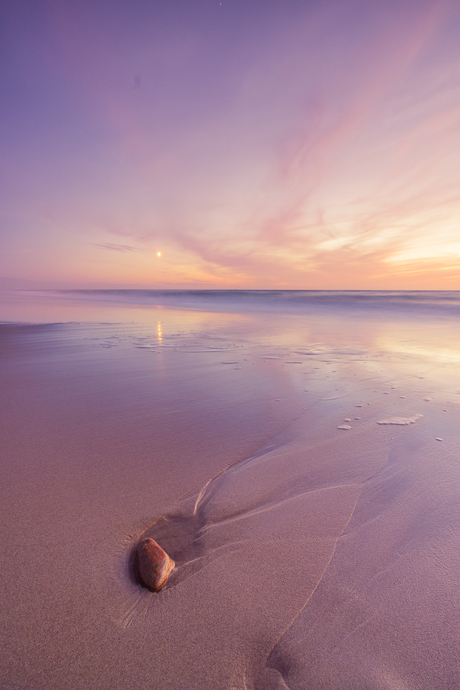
[0,290,460,389]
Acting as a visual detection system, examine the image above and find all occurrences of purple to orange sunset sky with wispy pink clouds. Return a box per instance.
[0,0,460,290]
